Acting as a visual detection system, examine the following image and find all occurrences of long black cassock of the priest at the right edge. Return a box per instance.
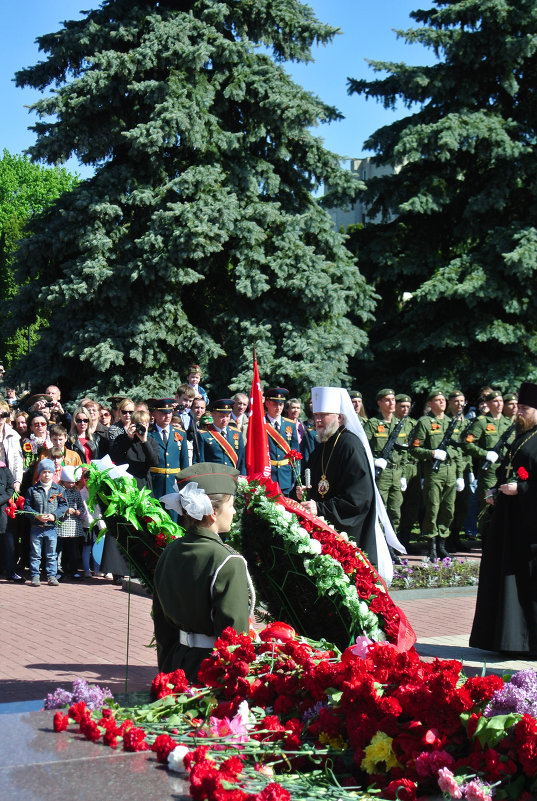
[470,426,537,656]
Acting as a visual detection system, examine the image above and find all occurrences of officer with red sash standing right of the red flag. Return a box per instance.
[265,387,300,496]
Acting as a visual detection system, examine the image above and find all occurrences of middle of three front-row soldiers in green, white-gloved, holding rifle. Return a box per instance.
[410,390,464,559]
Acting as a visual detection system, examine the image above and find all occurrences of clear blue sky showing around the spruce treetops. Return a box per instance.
[0,0,432,176]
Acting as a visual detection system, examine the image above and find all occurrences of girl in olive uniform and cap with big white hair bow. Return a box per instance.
[153,462,255,681]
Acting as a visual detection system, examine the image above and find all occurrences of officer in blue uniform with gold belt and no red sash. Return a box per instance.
[148,398,188,520]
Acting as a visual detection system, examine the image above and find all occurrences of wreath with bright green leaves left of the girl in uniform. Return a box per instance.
[87,463,184,594]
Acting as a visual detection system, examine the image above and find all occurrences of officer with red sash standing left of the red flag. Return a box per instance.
[199,398,246,476]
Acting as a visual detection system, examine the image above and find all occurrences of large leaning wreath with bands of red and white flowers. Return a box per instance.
[232,480,415,650]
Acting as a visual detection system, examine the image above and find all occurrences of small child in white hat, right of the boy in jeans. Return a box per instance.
[56,466,88,581]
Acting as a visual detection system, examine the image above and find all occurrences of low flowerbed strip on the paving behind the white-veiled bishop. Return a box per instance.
[390,556,479,590]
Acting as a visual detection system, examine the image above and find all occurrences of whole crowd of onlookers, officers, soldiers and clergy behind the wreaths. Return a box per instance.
[0,365,537,653]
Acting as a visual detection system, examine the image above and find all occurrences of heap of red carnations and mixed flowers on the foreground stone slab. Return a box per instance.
[54,623,537,801]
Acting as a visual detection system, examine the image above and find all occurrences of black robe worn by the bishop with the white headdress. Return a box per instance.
[306,426,377,565]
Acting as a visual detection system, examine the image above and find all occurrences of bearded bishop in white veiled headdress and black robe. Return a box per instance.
[296,387,404,582]
